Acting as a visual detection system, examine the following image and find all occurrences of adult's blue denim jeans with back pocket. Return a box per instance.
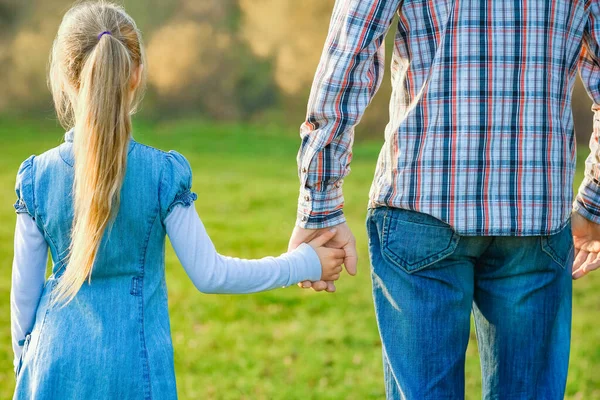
[367,207,573,400]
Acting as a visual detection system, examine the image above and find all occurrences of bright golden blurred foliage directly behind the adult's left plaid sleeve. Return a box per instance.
[239,0,393,138]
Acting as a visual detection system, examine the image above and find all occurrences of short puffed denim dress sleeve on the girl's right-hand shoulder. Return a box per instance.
[159,150,198,223]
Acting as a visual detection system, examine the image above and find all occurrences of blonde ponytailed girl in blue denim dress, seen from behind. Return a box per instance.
[11,2,344,400]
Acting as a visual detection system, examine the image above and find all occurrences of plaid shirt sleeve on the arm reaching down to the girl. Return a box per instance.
[296,0,400,229]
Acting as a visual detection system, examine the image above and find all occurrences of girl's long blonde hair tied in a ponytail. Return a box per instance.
[48,1,145,305]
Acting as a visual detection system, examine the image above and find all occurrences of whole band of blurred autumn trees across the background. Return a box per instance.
[0,0,592,143]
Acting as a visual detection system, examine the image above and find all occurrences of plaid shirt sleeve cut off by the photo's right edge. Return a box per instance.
[573,0,600,223]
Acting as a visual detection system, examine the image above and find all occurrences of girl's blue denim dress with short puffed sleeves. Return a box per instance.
[14,132,196,400]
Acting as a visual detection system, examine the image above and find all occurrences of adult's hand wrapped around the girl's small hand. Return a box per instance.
[288,223,358,292]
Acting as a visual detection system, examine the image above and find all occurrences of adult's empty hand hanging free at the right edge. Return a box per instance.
[571,212,600,279]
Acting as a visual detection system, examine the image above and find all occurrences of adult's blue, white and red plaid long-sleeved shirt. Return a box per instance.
[297,0,600,236]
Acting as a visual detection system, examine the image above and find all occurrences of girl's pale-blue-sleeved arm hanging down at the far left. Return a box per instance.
[10,213,48,368]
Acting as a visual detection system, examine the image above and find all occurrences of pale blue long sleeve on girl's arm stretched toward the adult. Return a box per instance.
[165,205,321,293]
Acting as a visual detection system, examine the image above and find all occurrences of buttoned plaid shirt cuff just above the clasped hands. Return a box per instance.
[296,181,346,229]
